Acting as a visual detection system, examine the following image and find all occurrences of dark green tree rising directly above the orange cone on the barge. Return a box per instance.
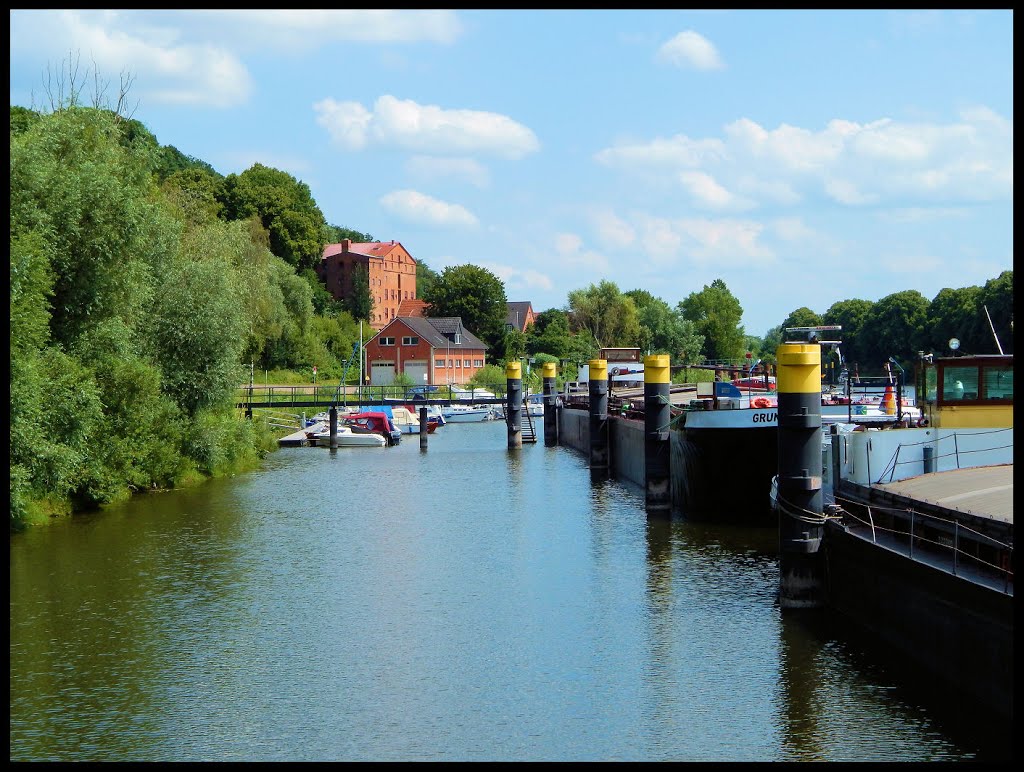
[858,290,929,375]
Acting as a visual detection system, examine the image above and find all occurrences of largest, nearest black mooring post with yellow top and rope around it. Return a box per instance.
[776,343,824,608]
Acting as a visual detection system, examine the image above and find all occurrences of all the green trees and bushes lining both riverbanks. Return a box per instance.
[10,66,1013,528]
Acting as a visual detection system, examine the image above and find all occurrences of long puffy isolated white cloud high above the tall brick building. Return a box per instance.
[313,94,540,160]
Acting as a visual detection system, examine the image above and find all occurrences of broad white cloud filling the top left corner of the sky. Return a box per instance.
[10,9,462,108]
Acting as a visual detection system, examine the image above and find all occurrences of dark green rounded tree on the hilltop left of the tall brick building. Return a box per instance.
[221,164,328,270]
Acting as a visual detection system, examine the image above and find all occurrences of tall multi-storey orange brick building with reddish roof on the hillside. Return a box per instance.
[316,239,416,330]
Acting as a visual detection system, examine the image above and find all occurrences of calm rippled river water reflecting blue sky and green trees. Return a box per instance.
[4,421,1006,762]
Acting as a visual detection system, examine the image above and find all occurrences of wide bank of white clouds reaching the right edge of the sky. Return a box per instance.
[594,106,1013,211]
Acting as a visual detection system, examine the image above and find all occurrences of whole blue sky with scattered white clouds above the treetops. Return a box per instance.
[10,9,1014,336]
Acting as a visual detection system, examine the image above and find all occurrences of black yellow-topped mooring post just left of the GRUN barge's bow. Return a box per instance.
[643,354,672,515]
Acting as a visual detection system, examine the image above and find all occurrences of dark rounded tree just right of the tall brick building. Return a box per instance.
[422,264,508,350]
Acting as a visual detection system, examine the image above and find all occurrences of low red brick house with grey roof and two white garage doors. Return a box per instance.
[365,316,487,386]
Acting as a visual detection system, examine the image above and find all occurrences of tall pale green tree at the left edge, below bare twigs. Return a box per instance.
[10,109,174,345]
